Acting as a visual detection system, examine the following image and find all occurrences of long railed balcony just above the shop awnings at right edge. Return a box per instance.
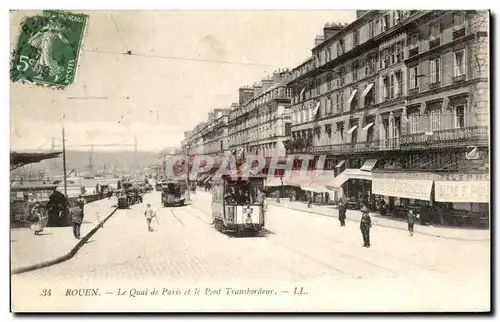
[401,126,489,150]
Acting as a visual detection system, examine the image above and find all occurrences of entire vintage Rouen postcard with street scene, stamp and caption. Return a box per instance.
[10,9,491,312]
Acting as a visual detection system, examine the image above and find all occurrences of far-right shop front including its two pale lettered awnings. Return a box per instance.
[372,171,490,227]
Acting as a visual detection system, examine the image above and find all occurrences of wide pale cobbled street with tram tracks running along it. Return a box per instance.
[12,192,490,310]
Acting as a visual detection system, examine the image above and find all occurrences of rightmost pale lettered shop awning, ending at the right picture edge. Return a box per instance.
[434,181,490,203]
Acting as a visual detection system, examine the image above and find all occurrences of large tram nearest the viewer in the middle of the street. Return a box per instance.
[212,174,265,235]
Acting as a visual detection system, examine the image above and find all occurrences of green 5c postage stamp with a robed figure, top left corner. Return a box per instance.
[10,10,87,87]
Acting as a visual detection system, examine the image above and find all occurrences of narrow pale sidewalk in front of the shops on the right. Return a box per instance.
[266,198,490,241]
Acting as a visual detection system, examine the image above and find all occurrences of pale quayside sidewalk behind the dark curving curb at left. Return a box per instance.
[10,197,116,271]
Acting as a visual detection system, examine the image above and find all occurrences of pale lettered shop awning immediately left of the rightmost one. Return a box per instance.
[367,177,434,201]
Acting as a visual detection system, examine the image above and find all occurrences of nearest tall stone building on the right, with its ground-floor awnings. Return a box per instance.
[288,10,489,226]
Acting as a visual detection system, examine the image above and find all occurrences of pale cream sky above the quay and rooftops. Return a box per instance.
[10,11,355,151]
